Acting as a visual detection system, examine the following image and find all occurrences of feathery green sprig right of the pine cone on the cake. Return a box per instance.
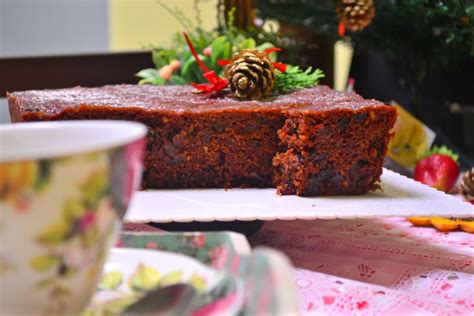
[273,66,324,93]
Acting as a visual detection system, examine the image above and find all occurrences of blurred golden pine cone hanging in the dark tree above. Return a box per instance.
[336,0,375,32]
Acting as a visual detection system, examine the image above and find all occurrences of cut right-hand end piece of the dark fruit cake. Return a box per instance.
[273,101,396,196]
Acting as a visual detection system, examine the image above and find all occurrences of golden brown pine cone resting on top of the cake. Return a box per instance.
[224,49,275,100]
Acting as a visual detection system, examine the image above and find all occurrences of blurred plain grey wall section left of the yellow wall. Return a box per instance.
[0,0,109,57]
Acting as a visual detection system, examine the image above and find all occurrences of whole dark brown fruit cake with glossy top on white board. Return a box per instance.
[8,85,396,195]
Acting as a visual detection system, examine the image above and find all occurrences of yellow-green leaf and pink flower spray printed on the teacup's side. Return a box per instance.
[30,168,113,312]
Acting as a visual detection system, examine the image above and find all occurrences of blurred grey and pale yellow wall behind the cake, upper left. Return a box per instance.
[0,0,217,123]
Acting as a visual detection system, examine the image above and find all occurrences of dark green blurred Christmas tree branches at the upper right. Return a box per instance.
[258,0,474,114]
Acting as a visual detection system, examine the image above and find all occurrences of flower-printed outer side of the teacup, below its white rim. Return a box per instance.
[0,142,143,315]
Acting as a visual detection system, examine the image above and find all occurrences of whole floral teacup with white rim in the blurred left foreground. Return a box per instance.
[0,121,146,315]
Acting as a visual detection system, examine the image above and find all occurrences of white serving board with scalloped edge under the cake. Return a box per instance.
[125,169,474,223]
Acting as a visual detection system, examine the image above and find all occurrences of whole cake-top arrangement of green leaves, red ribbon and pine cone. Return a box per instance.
[137,6,324,100]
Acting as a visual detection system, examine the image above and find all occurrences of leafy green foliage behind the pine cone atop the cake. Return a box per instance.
[136,1,291,85]
